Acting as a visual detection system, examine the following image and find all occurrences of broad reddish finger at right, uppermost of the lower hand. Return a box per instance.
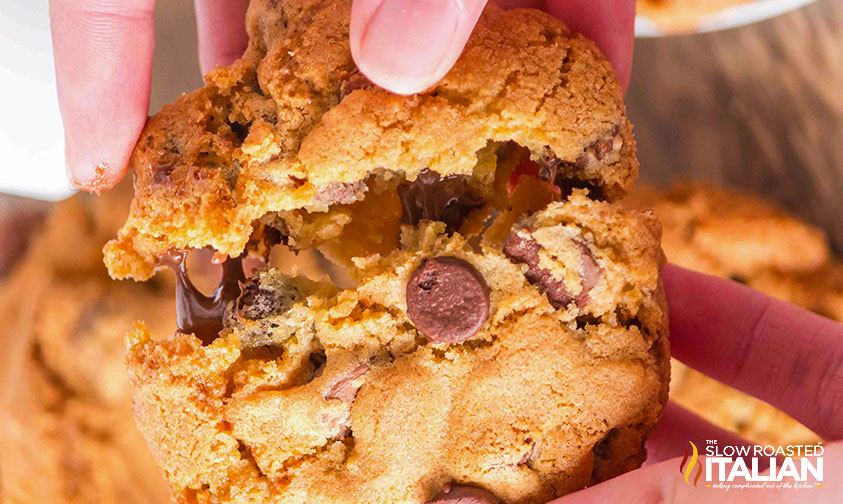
[664,265,843,439]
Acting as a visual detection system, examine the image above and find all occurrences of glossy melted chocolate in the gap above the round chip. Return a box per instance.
[398,168,483,233]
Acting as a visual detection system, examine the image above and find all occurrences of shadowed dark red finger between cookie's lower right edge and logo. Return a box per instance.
[645,401,766,469]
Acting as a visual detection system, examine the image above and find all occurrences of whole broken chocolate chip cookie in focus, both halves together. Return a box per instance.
[100,0,669,504]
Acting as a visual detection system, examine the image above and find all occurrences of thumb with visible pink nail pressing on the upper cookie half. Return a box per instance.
[350,0,486,94]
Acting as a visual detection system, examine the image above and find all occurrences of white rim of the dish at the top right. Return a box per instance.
[635,0,815,37]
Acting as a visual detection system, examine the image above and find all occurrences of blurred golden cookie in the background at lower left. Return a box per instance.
[0,184,174,503]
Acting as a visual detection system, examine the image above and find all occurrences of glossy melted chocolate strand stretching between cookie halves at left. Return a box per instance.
[160,252,246,345]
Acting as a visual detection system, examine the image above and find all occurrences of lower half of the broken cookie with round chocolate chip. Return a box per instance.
[128,194,669,504]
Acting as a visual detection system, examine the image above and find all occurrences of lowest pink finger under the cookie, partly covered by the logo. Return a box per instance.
[548,443,843,504]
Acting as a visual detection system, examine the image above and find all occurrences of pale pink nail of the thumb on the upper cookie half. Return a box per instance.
[358,0,461,94]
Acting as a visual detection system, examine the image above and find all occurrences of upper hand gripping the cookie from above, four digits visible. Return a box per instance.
[50,0,635,192]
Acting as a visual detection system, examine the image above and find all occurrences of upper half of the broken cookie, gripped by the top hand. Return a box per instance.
[105,0,637,279]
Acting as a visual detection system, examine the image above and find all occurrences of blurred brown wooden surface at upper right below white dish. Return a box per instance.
[627,0,843,252]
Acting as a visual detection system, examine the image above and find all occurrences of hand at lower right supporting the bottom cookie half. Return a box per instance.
[553,266,843,504]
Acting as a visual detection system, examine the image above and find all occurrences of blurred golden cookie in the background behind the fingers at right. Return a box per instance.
[627,182,843,444]
